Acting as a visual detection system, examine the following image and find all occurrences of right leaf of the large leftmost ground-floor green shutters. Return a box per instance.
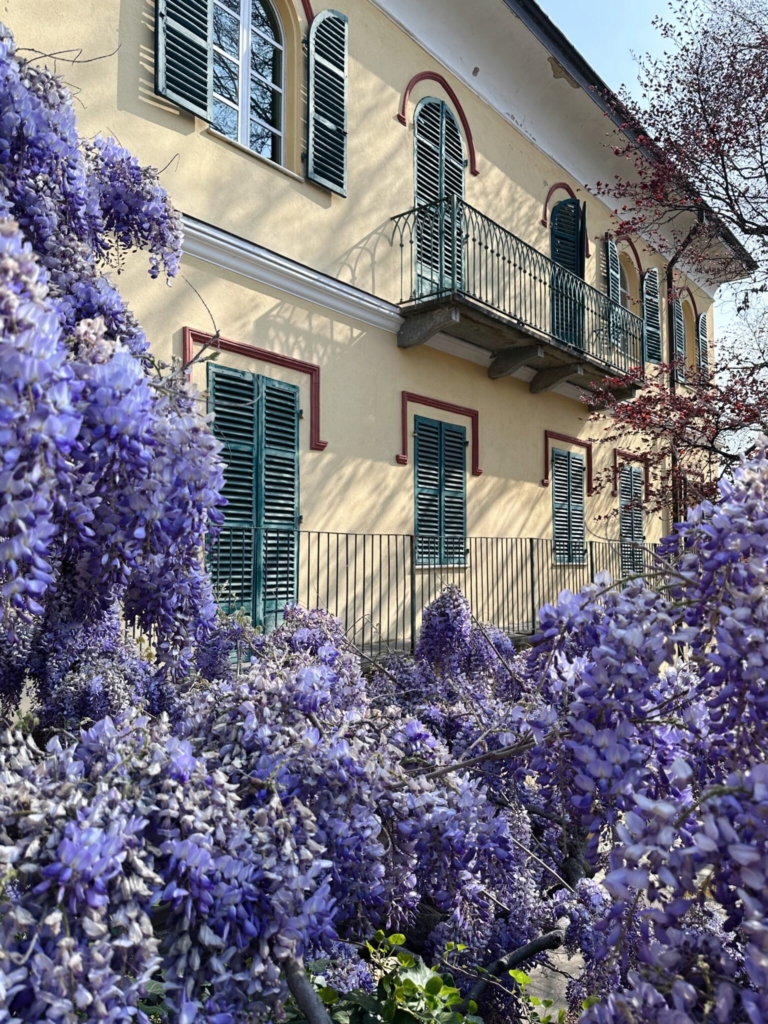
[256,377,299,629]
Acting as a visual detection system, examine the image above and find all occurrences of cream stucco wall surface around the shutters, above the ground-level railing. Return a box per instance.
[0,0,713,552]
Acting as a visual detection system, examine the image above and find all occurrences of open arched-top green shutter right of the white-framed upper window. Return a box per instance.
[307,10,348,196]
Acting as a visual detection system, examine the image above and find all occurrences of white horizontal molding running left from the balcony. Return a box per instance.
[182,214,402,334]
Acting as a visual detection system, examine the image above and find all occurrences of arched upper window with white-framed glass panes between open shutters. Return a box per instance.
[213,0,285,163]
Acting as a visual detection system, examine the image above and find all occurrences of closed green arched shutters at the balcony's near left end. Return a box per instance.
[414,97,464,297]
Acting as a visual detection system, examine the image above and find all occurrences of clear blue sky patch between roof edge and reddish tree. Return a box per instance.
[539,0,669,99]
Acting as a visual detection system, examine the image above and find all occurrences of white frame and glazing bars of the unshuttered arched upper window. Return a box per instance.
[213,0,286,166]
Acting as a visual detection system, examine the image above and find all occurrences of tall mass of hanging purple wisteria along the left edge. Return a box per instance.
[0,19,222,723]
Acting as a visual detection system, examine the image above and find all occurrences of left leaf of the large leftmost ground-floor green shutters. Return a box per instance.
[208,362,257,615]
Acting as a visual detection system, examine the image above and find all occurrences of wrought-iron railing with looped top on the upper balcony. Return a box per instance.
[392,196,643,373]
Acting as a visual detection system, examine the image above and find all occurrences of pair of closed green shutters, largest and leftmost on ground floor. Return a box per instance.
[208,362,299,628]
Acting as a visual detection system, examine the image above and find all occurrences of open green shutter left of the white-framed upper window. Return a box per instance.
[155,0,213,121]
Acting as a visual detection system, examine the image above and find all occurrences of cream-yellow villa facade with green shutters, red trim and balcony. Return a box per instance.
[3,0,714,637]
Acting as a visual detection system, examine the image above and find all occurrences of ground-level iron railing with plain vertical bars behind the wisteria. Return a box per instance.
[202,526,651,656]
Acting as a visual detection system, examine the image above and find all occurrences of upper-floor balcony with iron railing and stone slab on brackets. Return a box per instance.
[392,197,643,394]
